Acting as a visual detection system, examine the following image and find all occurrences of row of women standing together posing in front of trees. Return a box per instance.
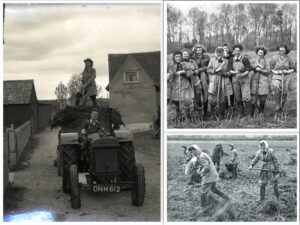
[167,44,296,120]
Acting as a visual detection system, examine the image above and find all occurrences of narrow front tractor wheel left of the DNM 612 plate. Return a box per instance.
[70,165,81,209]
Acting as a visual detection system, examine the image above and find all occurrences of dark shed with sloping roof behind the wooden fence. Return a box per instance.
[3,80,51,132]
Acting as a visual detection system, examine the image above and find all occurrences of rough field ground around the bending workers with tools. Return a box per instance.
[167,140,297,222]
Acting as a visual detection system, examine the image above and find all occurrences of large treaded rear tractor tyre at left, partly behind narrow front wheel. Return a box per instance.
[61,145,77,193]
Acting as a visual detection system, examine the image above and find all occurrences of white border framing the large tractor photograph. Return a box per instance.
[0,0,164,225]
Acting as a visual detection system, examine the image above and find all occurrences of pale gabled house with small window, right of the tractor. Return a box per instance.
[106,51,160,125]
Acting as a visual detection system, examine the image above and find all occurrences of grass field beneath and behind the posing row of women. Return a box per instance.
[168,51,298,129]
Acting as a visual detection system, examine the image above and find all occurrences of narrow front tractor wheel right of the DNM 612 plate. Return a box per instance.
[131,164,146,206]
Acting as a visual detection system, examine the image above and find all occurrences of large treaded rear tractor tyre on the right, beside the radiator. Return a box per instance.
[118,141,135,181]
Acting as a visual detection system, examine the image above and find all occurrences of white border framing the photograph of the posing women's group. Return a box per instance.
[162,1,300,133]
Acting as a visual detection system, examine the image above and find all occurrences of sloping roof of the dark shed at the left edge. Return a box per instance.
[3,80,34,105]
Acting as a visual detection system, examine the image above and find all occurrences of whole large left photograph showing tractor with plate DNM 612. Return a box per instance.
[3,1,162,222]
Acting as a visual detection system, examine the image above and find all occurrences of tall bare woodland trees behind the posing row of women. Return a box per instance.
[167,3,297,52]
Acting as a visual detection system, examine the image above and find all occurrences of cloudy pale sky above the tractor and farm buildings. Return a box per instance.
[3,3,161,100]
